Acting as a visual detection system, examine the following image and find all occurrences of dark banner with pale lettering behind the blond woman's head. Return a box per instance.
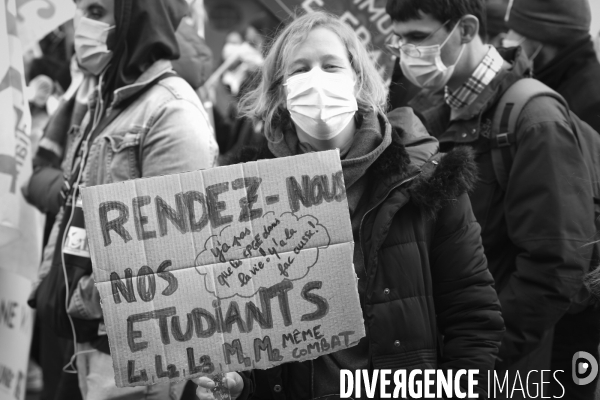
[261,0,396,81]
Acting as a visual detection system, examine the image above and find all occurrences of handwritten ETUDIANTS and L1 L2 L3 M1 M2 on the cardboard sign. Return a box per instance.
[127,281,329,383]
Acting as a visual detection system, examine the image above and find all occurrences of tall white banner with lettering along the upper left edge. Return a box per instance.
[0,0,44,280]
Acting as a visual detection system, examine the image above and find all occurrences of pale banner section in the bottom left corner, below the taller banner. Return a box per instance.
[0,268,33,400]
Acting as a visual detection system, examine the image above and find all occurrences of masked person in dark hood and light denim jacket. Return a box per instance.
[30,0,218,399]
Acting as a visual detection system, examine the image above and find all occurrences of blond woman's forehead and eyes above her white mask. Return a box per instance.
[284,27,356,80]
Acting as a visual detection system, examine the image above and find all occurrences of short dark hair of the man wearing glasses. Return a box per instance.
[385,0,487,40]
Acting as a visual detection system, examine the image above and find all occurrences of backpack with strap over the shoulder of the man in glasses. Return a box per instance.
[489,78,600,308]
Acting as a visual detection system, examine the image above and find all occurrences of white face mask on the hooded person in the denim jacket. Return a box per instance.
[75,16,115,76]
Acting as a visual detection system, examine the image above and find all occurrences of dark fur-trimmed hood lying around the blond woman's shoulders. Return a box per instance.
[234,108,477,217]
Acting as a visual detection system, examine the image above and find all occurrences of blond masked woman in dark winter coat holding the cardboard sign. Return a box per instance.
[196,12,504,399]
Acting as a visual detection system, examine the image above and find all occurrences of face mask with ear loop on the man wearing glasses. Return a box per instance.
[400,24,466,90]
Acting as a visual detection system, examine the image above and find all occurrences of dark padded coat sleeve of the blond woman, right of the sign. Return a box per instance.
[430,191,504,397]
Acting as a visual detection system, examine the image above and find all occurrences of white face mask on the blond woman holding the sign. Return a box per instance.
[284,68,358,140]
